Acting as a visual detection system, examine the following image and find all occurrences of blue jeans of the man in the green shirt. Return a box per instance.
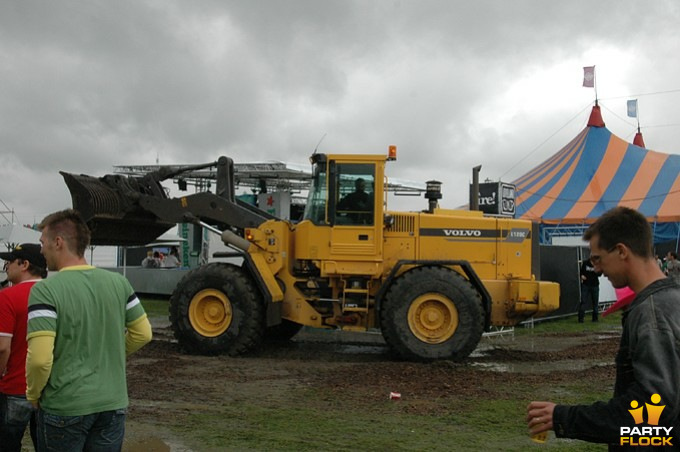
[37,409,127,452]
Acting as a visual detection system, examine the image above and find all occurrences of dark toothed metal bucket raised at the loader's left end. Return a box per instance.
[60,171,175,246]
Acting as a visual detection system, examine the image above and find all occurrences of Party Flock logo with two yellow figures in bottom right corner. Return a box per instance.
[620,394,673,446]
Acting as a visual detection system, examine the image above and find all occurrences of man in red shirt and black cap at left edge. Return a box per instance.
[0,243,47,451]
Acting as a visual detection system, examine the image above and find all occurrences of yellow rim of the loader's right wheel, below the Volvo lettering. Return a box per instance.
[408,293,458,344]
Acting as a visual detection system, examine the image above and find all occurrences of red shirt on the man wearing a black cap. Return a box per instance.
[0,280,38,395]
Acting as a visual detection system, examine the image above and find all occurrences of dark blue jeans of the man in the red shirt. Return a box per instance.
[0,393,35,452]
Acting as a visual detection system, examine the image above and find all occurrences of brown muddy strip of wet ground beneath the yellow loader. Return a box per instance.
[118,322,620,452]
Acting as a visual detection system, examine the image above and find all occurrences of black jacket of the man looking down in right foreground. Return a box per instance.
[553,278,680,451]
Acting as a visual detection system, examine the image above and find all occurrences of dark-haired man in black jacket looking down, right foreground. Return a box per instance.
[527,207,680,450]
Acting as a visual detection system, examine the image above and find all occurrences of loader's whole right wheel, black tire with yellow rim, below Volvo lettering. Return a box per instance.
[380,267,484,361]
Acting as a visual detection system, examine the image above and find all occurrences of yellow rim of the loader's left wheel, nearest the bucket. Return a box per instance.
[189,289,232,337]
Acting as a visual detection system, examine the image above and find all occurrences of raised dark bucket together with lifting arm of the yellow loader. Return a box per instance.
[60,157,274,246]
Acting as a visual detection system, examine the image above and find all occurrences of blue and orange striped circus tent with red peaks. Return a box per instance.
[513,104,680,244]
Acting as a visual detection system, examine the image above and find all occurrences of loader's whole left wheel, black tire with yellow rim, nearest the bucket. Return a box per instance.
[170,263,265,356]
